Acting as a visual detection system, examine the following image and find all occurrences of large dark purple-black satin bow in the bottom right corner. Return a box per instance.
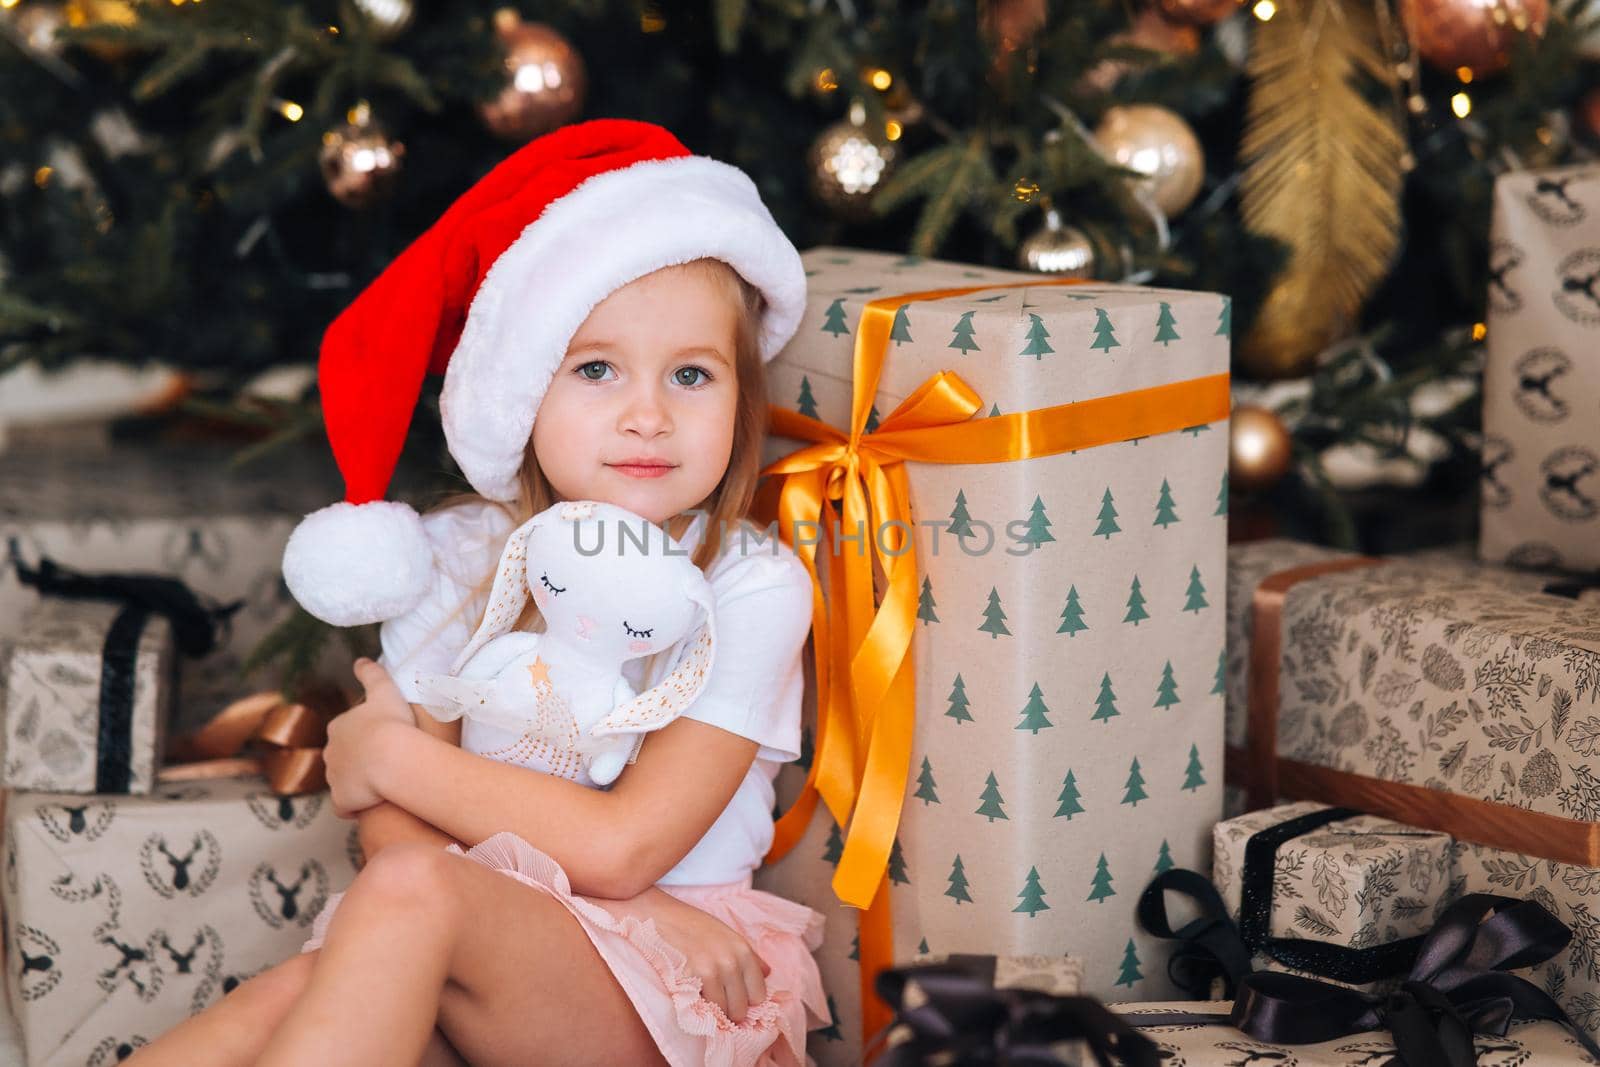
[1230,893,1600,1067]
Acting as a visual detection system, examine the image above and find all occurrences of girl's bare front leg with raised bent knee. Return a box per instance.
[259,843,662,1067]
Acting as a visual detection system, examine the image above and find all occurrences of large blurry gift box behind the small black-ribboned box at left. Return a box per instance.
[0,437,341,728]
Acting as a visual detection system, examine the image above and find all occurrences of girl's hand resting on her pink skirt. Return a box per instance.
[594,886,771,1022]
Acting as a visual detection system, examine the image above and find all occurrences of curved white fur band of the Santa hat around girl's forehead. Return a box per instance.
[440,155,806,501]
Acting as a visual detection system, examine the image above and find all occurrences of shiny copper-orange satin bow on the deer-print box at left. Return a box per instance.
[157,693,342,797]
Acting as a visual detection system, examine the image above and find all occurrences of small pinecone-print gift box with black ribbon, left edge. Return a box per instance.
[0,600,178,793]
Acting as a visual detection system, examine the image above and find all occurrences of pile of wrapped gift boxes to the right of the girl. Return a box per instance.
[757,175,1600,1067]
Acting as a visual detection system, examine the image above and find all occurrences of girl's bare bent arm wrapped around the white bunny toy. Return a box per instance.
[368,718,758,899]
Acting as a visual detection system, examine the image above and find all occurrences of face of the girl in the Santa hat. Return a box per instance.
[533,266,739,525]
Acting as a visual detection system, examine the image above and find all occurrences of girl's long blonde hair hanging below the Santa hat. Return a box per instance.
[429,258,768,643]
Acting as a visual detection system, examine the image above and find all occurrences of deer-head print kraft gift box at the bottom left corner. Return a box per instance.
[0,777,360,1067]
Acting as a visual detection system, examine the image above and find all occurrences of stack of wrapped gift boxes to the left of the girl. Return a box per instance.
[0,438,358,1067]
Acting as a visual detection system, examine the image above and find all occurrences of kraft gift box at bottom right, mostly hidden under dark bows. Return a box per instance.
[1110,1000,1595,1067]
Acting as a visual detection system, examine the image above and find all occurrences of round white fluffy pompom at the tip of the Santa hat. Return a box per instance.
[283,501,434,625]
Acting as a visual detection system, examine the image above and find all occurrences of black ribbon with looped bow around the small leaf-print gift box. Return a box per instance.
[1136,808,1422,1000]
